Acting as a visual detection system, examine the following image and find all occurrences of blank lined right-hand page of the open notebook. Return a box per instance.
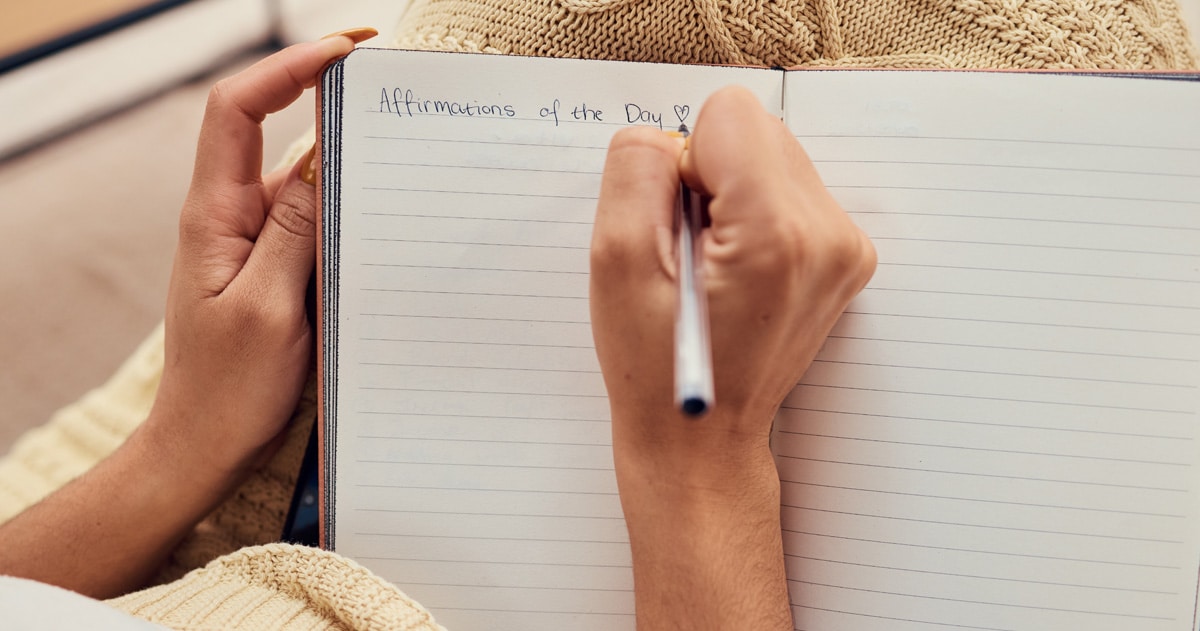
[773,72,1200,631]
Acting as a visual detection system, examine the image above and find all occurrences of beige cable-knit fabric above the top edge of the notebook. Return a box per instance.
[397,0,1196,70]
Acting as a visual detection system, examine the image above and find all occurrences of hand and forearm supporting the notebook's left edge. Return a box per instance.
[0,37,354,597]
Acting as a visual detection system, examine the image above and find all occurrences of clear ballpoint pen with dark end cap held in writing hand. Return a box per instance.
[674,125,713,416]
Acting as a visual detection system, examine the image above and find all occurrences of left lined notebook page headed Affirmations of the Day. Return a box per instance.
[332,50,781,630]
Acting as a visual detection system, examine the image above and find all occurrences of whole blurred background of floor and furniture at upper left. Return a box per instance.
[0,0,1200,453]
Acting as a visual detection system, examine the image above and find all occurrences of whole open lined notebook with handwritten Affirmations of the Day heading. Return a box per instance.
[322,49,1200,631]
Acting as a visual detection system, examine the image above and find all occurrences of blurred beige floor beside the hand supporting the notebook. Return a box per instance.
[0,0,1200,452]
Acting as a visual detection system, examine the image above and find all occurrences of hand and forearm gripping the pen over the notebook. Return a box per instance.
[592,88,875,630]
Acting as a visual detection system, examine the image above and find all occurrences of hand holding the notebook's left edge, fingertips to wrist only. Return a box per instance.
[146,30,373,476]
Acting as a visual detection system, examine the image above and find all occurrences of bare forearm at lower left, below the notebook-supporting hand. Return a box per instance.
[0,422,234,599]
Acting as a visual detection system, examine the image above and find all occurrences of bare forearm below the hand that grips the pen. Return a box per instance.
[618,421,792,631]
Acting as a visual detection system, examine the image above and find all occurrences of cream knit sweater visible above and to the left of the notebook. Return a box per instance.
[0,0,1196,631]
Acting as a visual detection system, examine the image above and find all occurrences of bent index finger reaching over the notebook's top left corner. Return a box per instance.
[193,37,354,184]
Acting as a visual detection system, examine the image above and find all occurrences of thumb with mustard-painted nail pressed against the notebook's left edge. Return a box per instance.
[239,160,317,305]
